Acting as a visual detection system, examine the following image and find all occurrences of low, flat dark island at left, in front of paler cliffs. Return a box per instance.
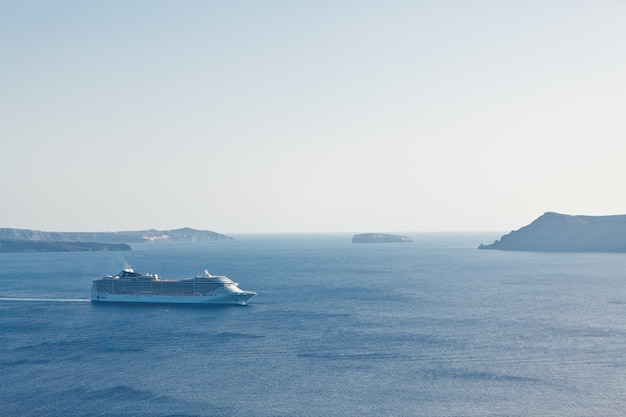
[0,240,132,253]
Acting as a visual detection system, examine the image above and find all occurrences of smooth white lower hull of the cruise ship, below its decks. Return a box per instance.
[91,291,256,305]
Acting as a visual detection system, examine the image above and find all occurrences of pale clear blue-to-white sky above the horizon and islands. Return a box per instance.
[0,0,626,234]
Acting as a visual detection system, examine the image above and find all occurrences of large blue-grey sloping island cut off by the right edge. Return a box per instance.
[479,212,626,252]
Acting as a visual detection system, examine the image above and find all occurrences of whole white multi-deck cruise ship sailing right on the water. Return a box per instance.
[91,268,256,305]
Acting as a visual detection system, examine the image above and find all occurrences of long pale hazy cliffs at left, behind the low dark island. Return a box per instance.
[0,227,232,243]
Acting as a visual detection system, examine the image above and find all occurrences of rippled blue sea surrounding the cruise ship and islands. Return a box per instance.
[0,233,626,417]
